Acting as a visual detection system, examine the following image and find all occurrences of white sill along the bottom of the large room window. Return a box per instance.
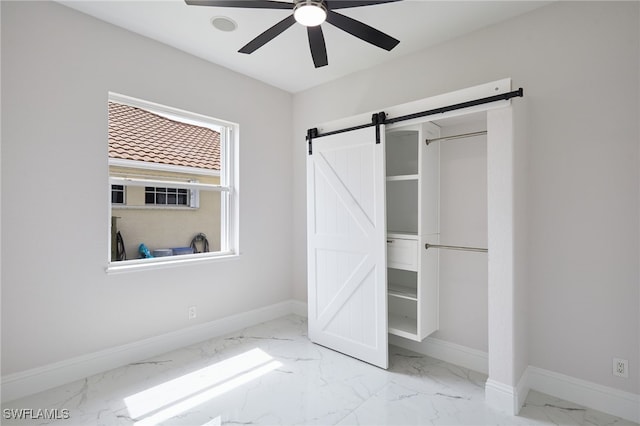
[105,252,240,275]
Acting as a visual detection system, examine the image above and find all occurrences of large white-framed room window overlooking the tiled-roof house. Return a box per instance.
[108,93,238,268]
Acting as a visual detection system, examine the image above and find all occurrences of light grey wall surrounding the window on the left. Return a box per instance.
[1,2,292,375]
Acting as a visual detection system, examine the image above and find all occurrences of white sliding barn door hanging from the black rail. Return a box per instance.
[307,125,388,368]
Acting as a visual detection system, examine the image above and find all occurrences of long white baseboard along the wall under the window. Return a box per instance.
[1,300,306,402]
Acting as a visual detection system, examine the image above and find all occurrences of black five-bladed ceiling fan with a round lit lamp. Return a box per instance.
[185,0,401,68]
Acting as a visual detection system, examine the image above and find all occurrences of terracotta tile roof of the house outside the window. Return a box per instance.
[109,102,220,170]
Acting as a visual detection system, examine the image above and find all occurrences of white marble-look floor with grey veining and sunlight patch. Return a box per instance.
[2,315,635,426]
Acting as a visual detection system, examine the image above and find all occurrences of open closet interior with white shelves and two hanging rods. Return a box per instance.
[385,112,487,349]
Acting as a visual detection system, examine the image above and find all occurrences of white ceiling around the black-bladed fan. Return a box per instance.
[59,0,549,93]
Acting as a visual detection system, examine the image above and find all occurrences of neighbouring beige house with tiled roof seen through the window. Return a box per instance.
[109,101,221,260]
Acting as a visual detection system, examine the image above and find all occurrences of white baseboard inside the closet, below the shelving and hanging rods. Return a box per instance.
[389,335,489,374]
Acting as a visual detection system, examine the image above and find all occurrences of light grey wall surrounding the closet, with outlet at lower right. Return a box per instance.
[293,2,640,393]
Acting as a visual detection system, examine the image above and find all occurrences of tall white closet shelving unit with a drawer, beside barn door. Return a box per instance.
[385,123,440,341]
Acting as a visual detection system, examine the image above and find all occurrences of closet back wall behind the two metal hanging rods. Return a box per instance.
[433,118,488,352]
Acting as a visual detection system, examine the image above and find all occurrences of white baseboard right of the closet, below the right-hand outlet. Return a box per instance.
[525,366,640,423]
